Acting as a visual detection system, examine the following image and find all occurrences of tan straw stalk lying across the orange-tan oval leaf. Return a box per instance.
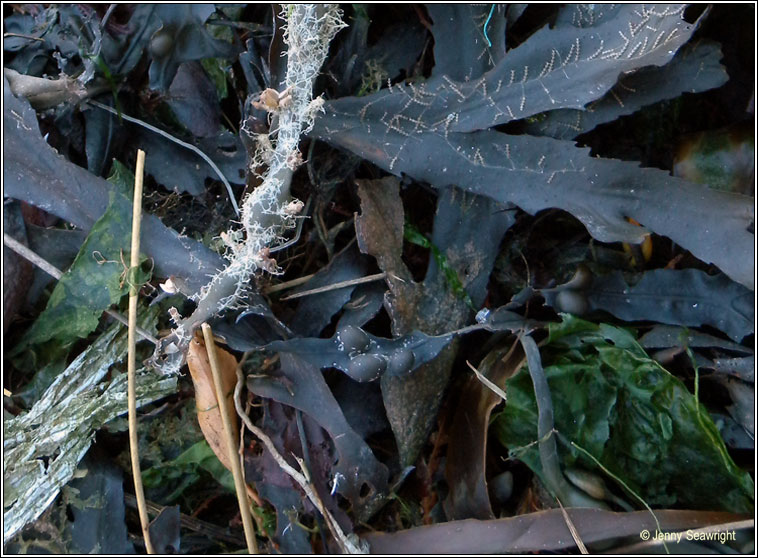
[202,323,258,554]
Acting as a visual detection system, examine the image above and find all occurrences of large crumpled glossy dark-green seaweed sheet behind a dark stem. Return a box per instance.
[493,315,753,513]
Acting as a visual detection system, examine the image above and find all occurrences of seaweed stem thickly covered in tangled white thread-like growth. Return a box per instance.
[166,4,345,345]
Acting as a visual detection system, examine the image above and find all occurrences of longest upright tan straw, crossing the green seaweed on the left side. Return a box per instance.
[127,149,155,554]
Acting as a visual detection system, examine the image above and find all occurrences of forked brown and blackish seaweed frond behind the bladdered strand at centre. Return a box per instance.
[356,177,513,465]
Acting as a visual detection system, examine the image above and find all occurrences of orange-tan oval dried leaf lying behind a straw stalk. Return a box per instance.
[187,339,239,471]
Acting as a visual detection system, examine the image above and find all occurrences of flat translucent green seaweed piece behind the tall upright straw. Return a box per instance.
[13,162,146,354]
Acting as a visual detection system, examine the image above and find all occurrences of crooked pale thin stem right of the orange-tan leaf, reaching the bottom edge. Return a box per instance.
[234,366,368,554]
